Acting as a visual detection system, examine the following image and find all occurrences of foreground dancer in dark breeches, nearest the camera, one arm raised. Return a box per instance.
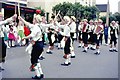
[19,16,44,79]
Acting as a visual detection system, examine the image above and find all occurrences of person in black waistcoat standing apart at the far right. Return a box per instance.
[108,21,118,52]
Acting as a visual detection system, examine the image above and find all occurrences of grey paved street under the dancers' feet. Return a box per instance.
[2,42,118,78]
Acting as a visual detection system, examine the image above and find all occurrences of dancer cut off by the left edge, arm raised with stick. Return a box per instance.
[0,14,17,70]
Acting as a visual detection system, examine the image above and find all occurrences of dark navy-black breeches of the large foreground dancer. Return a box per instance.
[31,41,43,65]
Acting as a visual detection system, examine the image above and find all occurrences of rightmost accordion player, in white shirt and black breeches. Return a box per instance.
[93,19,104,55]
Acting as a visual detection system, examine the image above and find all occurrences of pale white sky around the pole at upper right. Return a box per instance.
[96,0,120,13]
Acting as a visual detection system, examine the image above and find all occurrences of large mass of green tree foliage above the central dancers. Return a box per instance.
[52,2,99,20]
